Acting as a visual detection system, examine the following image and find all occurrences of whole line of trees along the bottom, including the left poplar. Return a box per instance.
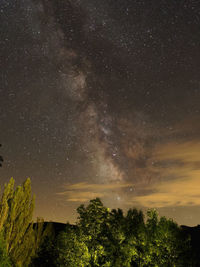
[0,165,196,267]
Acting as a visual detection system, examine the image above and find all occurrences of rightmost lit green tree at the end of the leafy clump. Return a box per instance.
[146,210,190,266]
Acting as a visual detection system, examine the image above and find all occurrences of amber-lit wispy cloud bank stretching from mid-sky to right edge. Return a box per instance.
[57,141,200,208]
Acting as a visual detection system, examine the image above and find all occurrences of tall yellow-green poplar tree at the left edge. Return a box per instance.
[0,178,34,266]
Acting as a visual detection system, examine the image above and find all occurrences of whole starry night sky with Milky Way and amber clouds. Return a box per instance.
[0,0,200,225]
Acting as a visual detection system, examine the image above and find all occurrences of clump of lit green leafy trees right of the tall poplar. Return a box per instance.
[53,198,191,267]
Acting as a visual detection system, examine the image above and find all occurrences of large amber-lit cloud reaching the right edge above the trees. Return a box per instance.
[130,141,200,208]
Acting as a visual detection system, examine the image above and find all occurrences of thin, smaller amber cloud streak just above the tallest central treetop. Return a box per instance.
[57,182,133,202]
